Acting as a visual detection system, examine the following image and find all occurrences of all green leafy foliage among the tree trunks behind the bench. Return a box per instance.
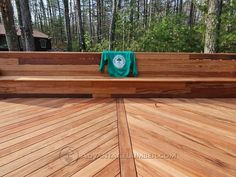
[31,0,236,52]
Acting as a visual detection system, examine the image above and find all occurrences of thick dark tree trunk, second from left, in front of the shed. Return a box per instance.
[20,0,35,51]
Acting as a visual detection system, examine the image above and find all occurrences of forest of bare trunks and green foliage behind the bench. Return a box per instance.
[0,0,236,53]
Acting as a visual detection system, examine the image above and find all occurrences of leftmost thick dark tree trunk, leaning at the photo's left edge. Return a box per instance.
[0,0,20,51]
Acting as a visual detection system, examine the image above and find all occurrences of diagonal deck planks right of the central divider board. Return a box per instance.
[125,99,236,177]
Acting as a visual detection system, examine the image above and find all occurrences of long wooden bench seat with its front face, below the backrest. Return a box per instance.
[0,76,236,97]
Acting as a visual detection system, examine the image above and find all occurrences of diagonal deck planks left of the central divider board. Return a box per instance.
[0,98,120,176]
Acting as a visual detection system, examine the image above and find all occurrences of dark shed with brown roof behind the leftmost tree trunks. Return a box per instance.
[0,24,52,51]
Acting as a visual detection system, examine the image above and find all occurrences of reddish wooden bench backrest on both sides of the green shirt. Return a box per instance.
[0,52,236,77]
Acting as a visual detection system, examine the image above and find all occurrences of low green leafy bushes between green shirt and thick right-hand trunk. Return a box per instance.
[112,16,203,52]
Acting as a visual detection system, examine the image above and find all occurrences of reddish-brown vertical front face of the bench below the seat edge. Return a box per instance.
[0,79,236,97]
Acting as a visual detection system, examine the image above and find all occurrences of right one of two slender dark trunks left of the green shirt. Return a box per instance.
[77,0,86,51]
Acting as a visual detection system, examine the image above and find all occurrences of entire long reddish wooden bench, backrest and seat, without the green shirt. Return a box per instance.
[0,52,236,97]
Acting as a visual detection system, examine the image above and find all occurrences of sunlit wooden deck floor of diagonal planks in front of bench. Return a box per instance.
[0,98,236,177]
